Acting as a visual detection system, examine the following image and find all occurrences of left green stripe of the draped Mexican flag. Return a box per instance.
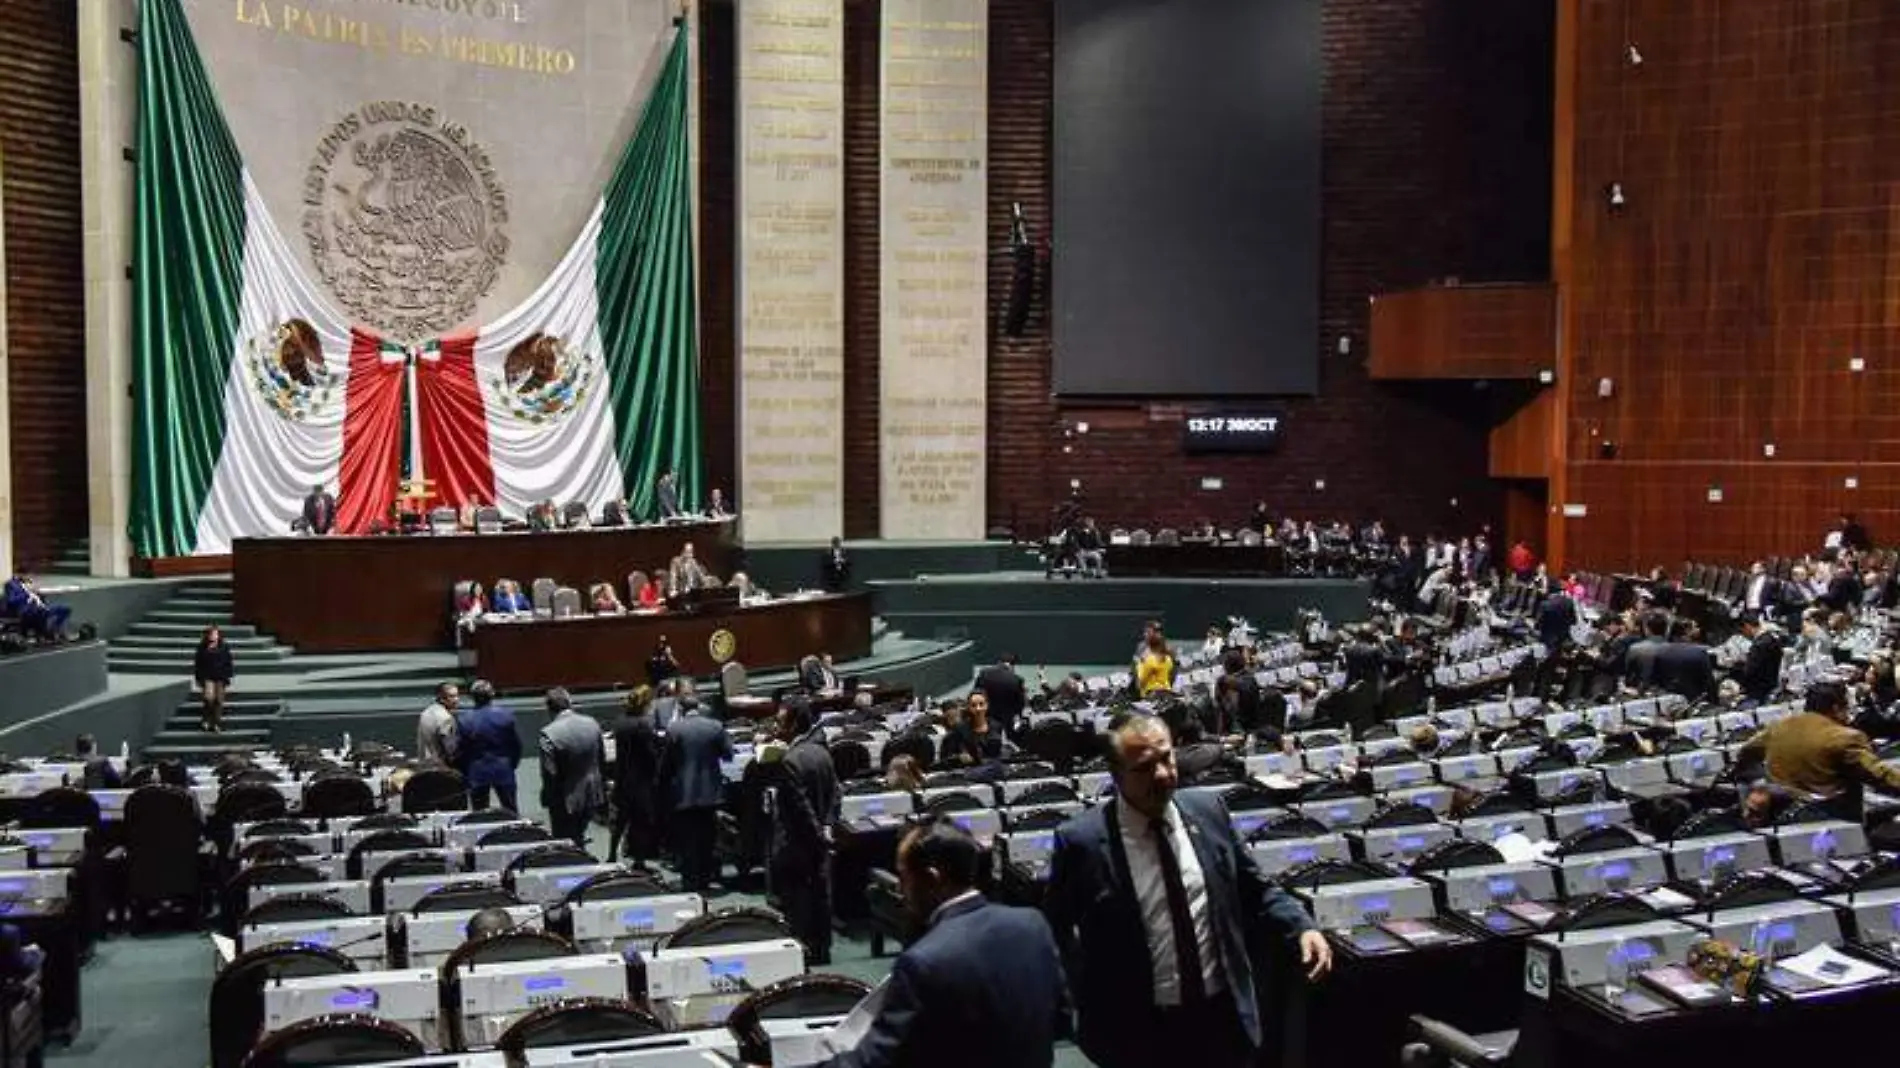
[131,0,245,557]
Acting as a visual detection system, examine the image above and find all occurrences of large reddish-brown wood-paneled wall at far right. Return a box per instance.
[1560,0,1900,566]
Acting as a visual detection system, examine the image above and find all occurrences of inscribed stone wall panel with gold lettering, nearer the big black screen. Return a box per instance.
[878,0,990,540]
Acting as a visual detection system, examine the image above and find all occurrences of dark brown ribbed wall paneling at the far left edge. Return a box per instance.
[0,0,87,570]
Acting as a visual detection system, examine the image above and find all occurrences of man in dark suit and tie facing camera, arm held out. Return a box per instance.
[1043,715,1332,1068]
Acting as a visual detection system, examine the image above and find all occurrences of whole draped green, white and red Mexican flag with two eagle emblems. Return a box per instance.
[133,0,701,559]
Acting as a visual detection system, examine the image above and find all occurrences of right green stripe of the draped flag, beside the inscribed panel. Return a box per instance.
[595,27,705,515]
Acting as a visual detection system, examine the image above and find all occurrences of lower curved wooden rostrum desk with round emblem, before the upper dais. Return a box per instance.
[471,593,870,690]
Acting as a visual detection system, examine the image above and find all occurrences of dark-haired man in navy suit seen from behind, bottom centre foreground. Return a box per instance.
[821,817,1071,1068]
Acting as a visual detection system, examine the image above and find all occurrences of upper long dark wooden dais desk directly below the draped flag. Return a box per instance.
[232,521,737,652]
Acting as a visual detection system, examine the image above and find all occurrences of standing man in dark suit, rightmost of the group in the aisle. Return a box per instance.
[771,697,840,967]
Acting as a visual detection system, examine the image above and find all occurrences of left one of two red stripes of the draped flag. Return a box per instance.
[336,331,403,534]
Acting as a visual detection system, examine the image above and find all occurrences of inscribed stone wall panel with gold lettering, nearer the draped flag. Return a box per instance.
[737,0,844,542]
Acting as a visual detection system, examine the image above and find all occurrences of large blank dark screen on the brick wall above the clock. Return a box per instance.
[1051,0,1322,397]
